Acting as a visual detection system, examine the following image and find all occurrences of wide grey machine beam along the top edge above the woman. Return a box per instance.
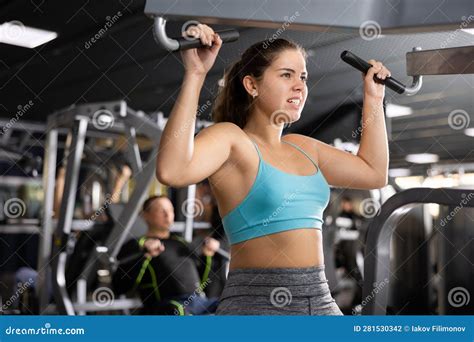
[145,0,474,35]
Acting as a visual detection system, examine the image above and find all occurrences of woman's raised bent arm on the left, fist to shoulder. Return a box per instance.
[156,25,237,187]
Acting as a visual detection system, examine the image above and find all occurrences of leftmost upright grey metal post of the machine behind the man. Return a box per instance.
[36,129,58,314]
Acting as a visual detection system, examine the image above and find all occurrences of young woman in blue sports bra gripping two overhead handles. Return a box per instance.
[156,25,390,315]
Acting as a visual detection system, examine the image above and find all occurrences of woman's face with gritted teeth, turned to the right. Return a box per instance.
[256,49,308,124]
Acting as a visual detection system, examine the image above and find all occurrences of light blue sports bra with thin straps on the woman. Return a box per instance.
[222,141,330,244]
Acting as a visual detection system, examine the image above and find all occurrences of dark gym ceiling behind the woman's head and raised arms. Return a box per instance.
[0,0,474,173]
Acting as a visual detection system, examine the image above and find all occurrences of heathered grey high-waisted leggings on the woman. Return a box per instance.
[216,266,342,315]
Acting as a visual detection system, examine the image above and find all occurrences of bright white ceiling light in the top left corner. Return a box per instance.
[0,21,58,49]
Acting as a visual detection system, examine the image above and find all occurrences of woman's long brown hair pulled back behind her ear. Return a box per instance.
[212,38,306,128]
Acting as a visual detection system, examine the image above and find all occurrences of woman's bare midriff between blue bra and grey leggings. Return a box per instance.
[230,228,324,269]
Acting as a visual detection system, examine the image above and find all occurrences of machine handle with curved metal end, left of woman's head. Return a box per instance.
[153,17,239,51]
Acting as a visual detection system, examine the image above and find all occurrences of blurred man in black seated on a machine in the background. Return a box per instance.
[113,196,219,315]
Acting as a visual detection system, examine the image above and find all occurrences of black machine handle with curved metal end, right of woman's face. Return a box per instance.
[341,48,422,96]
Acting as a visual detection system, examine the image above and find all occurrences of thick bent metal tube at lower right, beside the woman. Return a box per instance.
[362,188,474,315]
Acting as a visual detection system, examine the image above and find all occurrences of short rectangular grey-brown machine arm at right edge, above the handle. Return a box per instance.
[406,45,474,76]
